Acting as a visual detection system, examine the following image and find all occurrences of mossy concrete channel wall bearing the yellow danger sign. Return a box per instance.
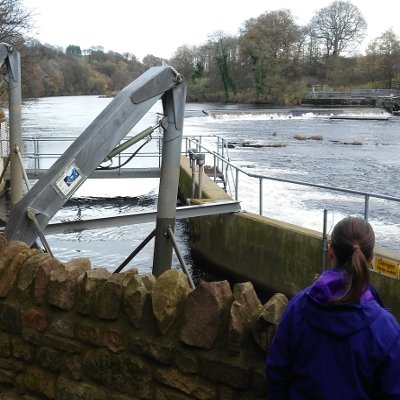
[180,157,400,320]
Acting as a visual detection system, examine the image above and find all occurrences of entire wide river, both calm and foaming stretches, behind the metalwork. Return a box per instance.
[17,96,400,272]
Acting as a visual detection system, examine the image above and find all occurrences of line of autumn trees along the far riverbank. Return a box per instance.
[0,0,400,104]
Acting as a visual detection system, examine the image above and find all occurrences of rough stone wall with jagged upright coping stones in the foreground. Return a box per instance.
[0,236,287,400]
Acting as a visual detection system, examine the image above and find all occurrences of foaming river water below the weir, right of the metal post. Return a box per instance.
[185,104,400,252]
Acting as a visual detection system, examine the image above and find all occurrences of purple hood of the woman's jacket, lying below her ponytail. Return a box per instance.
[304,269,380,337]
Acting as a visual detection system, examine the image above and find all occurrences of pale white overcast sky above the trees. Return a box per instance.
[22,0,400,60]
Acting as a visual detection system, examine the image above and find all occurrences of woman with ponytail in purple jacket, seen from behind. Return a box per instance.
[266,217,400,400]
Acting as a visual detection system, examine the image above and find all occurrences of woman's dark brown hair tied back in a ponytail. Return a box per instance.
[330,217,375,304]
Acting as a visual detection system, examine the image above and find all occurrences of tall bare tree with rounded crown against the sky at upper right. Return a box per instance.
[311,1,367,58]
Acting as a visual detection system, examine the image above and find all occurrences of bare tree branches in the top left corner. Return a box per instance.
[0,0,32,46]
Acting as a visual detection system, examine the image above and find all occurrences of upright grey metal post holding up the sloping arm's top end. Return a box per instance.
[153,80,186,277]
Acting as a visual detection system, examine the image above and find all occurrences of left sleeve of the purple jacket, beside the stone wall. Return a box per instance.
[265,299,295,400]
